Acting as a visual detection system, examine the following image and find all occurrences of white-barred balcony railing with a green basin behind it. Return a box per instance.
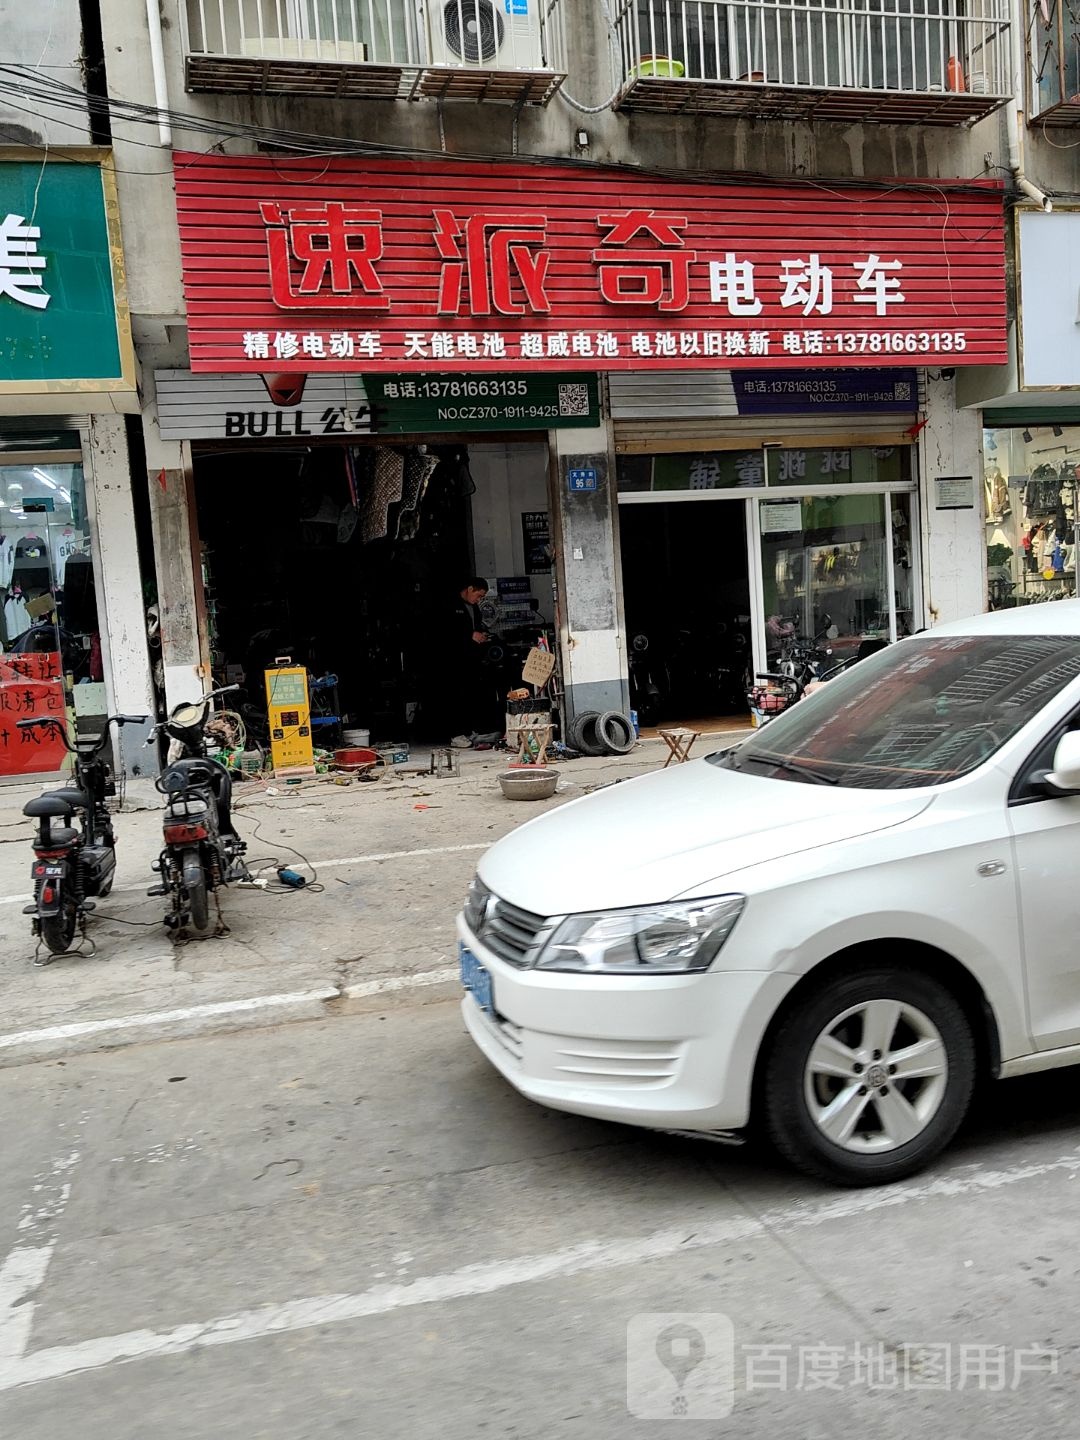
[616,0,1013,125]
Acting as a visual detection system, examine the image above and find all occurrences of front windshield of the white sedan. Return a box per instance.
[708,635,1080,791]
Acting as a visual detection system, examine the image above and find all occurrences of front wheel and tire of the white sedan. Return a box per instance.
[763,966,976,1185]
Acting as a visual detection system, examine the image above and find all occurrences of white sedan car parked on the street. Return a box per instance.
[458,600,1080,1185]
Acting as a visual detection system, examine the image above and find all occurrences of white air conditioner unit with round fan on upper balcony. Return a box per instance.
[425,0,547,71]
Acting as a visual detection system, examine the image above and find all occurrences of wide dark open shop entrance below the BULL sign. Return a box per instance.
[194,442,554,747]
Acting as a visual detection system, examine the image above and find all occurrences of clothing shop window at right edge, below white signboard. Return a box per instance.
[982,425,1080,611]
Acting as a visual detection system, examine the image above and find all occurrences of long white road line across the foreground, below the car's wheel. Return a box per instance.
[0,1152,1080,1391]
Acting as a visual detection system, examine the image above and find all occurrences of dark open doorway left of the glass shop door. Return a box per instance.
[619,500,750,726]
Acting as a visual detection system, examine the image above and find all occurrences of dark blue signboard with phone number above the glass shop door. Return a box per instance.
[732,370,919,415]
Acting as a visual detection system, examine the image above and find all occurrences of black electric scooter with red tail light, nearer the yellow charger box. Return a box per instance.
[147,685,251,935]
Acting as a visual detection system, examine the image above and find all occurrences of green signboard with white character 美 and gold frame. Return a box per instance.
[0,150,134,395]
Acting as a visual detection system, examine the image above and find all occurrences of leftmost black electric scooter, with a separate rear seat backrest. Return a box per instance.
[19,716,147,963]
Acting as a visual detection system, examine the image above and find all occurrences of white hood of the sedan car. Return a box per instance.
[480,760,933,914]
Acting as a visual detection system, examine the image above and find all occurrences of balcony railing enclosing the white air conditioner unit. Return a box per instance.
[180,0,576,105]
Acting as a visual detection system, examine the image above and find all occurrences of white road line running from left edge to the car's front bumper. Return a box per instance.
[0,965,458,1051]
